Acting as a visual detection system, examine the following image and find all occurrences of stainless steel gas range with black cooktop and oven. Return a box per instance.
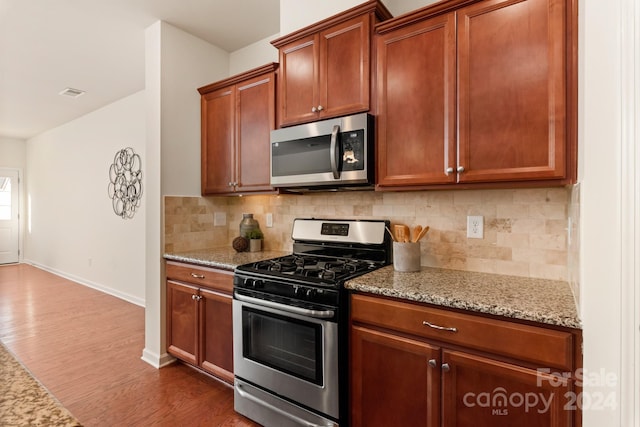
[233,219,391,427]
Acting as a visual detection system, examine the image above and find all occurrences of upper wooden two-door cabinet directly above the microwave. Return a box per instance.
[271,1,391,126]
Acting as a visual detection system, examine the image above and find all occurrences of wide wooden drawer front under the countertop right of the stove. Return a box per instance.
[351,294,573,370]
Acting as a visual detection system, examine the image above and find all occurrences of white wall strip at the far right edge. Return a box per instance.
[579,0,640,427]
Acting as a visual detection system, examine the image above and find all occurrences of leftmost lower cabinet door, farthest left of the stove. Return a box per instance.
[167,281,198,365]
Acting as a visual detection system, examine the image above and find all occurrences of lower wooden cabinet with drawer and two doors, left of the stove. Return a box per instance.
[167,262,233,384]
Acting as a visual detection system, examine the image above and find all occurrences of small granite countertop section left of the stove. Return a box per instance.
[164,247,290,270]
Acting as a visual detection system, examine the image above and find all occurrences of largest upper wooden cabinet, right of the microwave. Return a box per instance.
[376,0,577,189]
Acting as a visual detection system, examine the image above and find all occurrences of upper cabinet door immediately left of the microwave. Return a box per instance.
[236,73,275,191]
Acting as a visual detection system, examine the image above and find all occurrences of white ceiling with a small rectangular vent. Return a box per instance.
[0,0,280,139]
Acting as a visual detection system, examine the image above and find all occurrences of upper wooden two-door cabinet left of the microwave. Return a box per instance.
[198,64,278,195]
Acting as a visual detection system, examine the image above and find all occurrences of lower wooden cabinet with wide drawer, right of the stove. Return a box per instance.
[350,294,581,427]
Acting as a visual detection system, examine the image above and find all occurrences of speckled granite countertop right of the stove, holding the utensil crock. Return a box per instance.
[345,266,582,329]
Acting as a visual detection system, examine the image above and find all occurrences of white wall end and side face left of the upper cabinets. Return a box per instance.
[142,21,229,367]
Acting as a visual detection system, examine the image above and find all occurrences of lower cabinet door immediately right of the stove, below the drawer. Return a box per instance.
[349,326,440,427]
